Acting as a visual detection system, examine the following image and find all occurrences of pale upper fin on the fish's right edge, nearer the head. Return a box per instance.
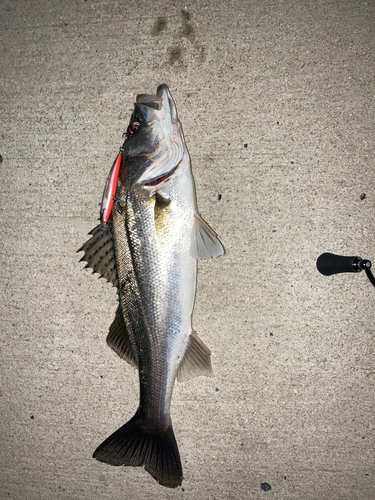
[192,214,225,259]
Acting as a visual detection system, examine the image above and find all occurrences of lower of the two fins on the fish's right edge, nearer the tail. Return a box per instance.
[177,332,212,382]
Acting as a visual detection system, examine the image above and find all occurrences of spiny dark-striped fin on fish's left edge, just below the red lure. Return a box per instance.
[77,224,118,286]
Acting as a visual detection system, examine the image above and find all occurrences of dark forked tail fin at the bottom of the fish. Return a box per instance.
[93,414,182,488]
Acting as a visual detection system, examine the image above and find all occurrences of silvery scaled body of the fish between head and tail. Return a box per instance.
[112,182,196,426]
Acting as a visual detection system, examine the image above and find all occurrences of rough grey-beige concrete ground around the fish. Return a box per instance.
[0,0,375,500]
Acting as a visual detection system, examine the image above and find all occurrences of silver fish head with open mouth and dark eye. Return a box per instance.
[121,85,185,196]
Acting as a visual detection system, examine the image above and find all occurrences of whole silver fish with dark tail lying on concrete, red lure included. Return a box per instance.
[78,84,225,488]
